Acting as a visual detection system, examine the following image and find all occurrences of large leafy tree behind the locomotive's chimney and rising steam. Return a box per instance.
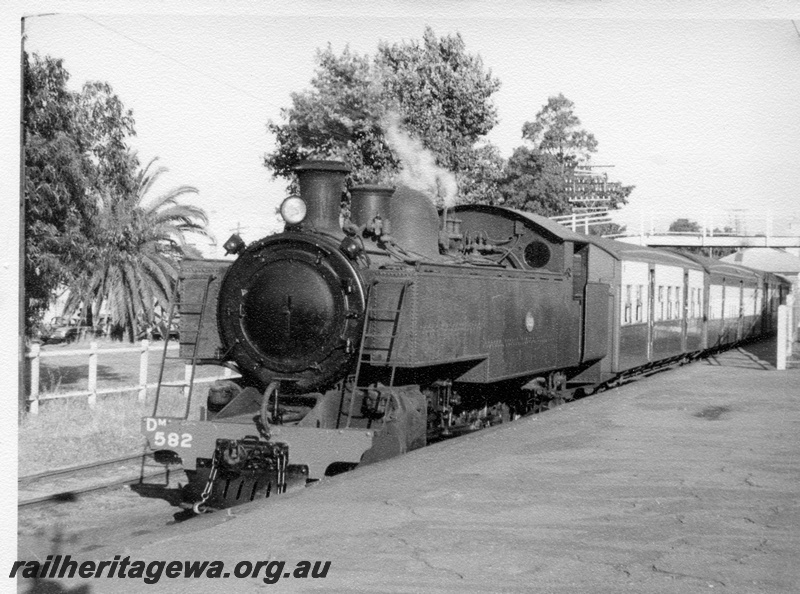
[265,27,500,199]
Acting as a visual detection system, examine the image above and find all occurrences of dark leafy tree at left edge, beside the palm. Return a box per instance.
[23,54,134,330]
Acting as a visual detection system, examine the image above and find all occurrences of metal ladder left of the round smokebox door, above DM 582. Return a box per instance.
[153,274,215,419]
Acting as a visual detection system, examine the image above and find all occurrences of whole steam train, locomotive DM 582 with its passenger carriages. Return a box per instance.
[142,161,789,511]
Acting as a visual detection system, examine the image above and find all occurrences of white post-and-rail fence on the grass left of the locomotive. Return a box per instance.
[25,340,237,415]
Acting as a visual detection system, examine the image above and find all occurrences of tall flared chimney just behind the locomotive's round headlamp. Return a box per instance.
[294,161,350,235]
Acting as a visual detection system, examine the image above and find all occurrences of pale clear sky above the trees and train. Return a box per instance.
[15,2,800,256]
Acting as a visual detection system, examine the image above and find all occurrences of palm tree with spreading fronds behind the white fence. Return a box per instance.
[65,158,212,342]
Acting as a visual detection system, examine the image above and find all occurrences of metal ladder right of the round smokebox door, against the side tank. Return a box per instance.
[336,279,413,428]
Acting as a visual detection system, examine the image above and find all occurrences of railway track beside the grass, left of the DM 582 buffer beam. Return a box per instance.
[17,454,169,509]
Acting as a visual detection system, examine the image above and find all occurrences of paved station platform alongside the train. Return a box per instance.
[28,343,800,594]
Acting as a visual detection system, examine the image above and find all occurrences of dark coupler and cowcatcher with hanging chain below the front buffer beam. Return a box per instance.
[186,436,308,513]
